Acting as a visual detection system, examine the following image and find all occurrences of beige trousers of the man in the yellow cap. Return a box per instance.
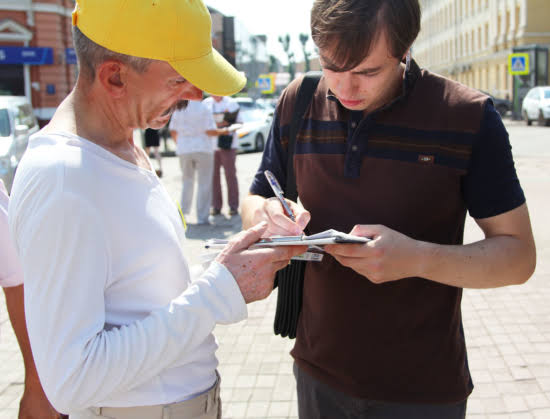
[69,375,222,419]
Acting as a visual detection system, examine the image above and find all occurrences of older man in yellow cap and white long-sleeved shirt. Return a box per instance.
[9,0,305,419]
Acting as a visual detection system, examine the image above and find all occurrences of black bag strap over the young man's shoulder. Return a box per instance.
[284,71,322,202]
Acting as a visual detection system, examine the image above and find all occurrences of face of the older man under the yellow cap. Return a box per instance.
[128,61,202,129]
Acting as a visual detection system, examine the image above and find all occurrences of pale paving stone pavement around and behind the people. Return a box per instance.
[0,124,550,419]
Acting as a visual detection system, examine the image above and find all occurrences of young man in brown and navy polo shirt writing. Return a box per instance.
[243,0,535,419]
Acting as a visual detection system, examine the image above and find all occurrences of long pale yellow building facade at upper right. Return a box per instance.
[413,0,550,98]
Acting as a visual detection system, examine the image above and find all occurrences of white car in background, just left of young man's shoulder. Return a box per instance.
[237,108,273,152]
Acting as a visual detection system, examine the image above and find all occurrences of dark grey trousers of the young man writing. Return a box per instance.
[294,363,466,419]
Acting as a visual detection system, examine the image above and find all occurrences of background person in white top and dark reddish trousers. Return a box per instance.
[204,95,243,216]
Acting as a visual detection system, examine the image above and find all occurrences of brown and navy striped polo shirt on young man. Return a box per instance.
[250,62,525,403]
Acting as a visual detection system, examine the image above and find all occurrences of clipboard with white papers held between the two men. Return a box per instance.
[204,229,371,249]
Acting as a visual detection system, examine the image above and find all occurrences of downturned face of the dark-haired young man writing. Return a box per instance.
[319,33,404,112]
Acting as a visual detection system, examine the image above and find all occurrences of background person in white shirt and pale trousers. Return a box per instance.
[168,101,229,224]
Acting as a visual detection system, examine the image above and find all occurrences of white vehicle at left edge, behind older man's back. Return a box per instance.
[0,96,40,191]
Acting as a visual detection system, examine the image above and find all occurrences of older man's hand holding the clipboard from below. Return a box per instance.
[216,222,307,304]
